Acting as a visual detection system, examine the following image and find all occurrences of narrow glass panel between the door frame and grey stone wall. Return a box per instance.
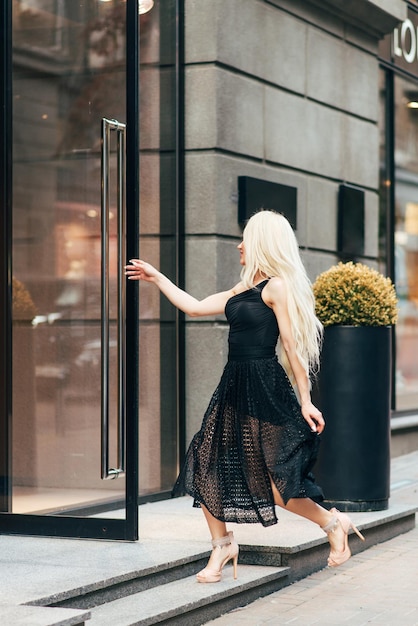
[139,0,178,495]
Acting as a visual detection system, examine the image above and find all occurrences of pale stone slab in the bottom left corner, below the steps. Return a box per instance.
[0,604,90,626]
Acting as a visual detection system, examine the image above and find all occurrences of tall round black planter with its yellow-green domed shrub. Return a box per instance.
[313,262,398,511]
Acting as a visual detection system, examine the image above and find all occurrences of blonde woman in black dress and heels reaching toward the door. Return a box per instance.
[125,211,363,582]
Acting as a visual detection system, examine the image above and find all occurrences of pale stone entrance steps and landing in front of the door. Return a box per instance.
[4,499,416,626]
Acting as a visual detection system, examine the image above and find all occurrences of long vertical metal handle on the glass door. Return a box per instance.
[101,118,126,479]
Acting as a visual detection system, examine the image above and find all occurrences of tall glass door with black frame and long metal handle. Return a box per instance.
[0,0,139,539]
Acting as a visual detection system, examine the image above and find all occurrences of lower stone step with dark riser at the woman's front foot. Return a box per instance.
[47,546,290,626]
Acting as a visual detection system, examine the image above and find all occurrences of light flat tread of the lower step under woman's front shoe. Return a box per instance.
[85,565,289,626]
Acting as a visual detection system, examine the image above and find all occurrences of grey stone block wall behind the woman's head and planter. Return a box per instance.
[185,0,406,440]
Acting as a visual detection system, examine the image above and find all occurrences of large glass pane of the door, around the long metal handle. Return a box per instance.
[13,0,126,513]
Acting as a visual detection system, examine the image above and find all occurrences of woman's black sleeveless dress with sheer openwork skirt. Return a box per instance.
[173,280,323,526]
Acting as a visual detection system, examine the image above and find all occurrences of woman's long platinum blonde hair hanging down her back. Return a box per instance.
[241,210,322,382]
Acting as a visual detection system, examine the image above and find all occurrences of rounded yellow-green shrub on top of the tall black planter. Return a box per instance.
[313,261,398,326]
